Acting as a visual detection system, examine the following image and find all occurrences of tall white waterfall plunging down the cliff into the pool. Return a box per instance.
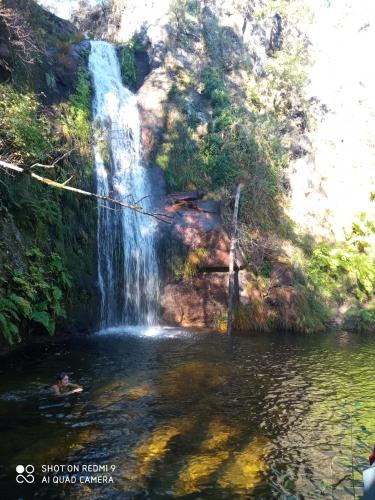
[89,41,158,329]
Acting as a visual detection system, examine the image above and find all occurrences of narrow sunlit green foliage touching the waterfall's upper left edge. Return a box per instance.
[61,67,91,156]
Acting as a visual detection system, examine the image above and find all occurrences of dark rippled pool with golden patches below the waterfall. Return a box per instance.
[0,329,375,499]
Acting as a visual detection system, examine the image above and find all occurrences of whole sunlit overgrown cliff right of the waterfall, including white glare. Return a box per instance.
[28,0,375,331]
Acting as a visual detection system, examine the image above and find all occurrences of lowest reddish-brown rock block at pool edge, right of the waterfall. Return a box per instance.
[161,273,228,328]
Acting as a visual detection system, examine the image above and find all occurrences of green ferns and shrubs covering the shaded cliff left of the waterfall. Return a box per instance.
[0,53,96,344]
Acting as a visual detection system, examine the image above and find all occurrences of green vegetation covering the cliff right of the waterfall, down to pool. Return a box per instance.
[156,0,375,332]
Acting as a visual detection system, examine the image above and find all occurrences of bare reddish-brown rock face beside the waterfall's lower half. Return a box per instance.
[161,192,245,328]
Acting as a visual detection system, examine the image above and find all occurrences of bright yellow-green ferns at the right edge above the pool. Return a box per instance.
[299,214,375,332]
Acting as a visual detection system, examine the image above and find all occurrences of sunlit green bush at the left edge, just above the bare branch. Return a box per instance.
[0,84,54,163]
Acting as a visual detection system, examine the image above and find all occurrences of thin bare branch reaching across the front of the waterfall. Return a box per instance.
[0,160,170,224]
